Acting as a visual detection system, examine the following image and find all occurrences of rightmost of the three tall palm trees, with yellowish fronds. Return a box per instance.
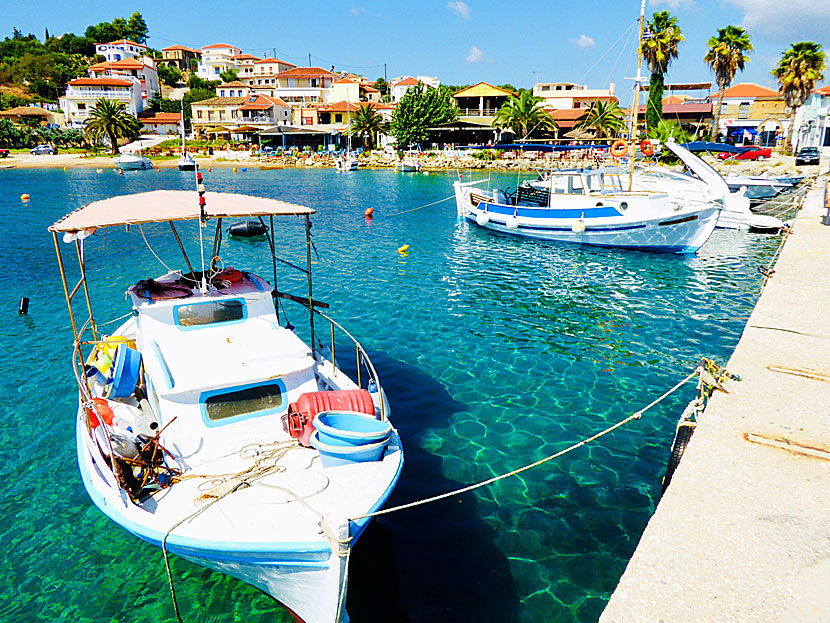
[771,41,827,153]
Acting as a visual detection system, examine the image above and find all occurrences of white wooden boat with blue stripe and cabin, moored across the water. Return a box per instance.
[454,167,721,253]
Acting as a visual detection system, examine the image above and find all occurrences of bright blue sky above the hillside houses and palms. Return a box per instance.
[6,0,830,103]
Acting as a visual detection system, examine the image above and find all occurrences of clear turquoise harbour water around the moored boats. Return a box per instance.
[0,169,778,623]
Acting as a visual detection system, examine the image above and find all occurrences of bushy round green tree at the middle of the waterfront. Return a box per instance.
[389,82,458,148]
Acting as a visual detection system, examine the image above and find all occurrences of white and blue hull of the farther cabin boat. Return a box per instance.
[456,183,720,253]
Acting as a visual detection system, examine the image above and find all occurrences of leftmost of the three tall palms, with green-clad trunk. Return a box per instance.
[643,11,684,129]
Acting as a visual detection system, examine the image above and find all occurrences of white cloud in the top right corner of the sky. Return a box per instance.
[725,0,830,43]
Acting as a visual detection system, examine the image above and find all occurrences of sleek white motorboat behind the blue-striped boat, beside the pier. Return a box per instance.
[632,141,784,232]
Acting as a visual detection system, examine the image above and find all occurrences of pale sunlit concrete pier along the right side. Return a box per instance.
[600,178,830,623]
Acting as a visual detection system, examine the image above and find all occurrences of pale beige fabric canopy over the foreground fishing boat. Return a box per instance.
[49,190,314,232]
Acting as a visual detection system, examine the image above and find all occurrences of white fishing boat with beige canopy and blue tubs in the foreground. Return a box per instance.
[49,186,403,623]
